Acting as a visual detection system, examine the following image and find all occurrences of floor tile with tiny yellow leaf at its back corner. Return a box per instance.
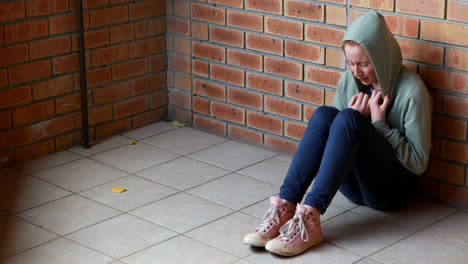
[91,142,179,173]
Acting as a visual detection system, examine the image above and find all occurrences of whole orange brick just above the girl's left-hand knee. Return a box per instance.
[285,81,325,105]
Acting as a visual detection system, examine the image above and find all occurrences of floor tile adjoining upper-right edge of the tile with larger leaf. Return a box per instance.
[136,157,230,190]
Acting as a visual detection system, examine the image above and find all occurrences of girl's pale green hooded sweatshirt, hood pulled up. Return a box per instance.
[333,11,432,175]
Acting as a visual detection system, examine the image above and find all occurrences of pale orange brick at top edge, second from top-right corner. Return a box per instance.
[396,0,445,18]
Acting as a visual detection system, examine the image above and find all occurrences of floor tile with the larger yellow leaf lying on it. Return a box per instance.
[80,175,177,211]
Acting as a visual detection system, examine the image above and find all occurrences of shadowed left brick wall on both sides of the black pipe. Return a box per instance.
[0,0,168,167]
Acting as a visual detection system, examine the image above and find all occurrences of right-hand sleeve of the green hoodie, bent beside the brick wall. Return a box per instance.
[373,87,432,175]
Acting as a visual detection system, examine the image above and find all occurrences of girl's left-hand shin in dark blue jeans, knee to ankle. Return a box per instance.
[279,106,339,204]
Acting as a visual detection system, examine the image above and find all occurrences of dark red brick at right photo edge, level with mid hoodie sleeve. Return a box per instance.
[432,115,467,140]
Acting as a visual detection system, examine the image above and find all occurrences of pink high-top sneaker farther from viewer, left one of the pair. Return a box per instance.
[244,196,296,247]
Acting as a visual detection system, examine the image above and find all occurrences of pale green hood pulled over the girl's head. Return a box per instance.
[342,11,403,98]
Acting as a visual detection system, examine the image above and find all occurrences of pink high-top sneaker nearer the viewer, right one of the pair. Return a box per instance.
[265,204,323,256]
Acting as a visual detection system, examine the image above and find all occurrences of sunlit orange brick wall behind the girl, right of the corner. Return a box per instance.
[166,0,468,208]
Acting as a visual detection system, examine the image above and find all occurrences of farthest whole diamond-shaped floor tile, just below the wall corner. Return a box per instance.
[143,127,227,155]
